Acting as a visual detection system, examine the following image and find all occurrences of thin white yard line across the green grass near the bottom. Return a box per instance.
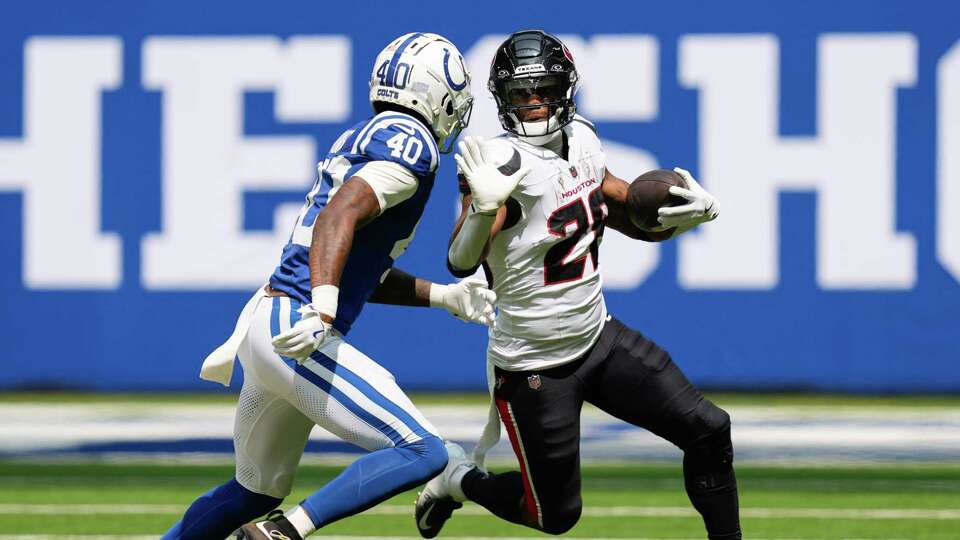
[0,504,960,520]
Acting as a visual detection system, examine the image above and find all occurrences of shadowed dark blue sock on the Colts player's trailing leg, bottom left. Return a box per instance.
[162,478,283,540]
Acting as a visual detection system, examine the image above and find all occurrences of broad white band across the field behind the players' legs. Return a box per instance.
[0,403,960,463]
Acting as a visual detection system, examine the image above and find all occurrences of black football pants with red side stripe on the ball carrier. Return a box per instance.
[462,318,740,540]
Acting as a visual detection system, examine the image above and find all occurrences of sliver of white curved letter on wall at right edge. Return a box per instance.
[937,42,960,281]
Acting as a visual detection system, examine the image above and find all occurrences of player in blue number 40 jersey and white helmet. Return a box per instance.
[164,33,494,540]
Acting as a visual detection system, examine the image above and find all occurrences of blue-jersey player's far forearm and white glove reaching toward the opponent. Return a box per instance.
[369,268,497,326]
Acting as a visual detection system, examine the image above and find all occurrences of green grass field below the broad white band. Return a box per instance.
[0,462,960,540]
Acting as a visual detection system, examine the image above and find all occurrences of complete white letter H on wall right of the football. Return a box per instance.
[679,34,917,289]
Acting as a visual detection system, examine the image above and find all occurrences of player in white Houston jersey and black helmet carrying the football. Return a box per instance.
[415,30,741,540]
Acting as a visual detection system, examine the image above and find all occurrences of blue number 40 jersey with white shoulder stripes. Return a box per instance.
[270,111,439,334]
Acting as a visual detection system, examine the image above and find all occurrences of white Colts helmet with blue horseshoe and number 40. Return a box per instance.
[370,32,473,154]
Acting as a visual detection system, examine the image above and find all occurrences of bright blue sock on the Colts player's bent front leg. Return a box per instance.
[300,436,447,529]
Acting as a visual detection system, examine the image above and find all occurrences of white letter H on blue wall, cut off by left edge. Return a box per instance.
[0,38,123,289]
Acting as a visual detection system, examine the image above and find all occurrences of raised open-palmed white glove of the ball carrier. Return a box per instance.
[453,137,530,214]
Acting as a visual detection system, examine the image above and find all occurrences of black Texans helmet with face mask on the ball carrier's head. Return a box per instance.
[487,30,579,137]
